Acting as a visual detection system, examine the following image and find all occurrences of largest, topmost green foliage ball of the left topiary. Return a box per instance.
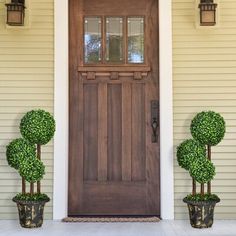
[20,110,55,145]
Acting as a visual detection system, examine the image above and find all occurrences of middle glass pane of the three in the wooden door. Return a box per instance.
[106,17,123,63]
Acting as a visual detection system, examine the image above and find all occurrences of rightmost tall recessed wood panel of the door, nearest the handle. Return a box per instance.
[132,84,146,180]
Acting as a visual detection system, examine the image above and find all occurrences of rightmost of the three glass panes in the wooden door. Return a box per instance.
[128,17,144,63]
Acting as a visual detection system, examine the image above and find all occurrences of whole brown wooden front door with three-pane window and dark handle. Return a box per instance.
[68,0,160,216]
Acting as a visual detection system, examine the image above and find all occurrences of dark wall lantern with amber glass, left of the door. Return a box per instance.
[6,0,25,26]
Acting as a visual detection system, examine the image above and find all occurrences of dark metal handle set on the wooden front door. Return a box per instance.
[151,100,159,143]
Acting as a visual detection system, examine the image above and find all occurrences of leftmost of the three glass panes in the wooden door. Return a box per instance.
[84,17,102,63]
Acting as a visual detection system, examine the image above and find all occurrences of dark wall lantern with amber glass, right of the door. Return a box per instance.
[198,0,217,26]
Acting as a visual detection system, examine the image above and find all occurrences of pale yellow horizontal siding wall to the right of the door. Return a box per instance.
[172,0,236,219]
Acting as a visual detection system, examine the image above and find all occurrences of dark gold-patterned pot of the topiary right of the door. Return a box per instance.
[183,198,220,229]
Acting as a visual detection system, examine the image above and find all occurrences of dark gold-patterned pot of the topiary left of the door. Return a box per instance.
[13,198,49,228]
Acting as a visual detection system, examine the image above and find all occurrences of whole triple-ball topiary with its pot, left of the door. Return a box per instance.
[6,110,55,228]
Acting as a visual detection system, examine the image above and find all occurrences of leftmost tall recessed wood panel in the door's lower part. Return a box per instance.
[84,84,98,180]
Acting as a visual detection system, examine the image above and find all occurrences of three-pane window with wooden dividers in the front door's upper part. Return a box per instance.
[83,16,145,65]
